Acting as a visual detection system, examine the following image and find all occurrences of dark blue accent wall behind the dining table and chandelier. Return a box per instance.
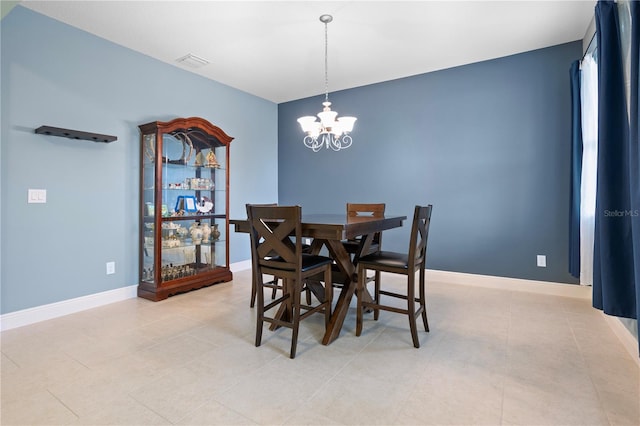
[278,41,582,283]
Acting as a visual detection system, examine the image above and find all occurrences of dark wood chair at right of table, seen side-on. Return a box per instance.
[356,204,433,348]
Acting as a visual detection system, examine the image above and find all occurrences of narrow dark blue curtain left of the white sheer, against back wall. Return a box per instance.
[569,61,582,278]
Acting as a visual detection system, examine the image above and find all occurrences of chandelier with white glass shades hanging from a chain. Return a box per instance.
[298,15,357,152]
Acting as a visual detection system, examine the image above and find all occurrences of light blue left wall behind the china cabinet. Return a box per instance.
[0,6,278,314]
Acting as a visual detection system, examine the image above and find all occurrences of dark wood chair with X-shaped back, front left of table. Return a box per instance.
[247,205,332,358]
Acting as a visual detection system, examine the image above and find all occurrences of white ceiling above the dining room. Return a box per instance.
[21,0,595,103]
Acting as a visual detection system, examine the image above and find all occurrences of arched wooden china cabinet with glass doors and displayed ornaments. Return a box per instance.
[138,117,233,301]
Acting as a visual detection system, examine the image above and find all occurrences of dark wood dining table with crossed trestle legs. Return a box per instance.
[229,212,407,345]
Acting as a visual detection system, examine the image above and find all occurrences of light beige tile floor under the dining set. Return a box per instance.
[0,271,640,425]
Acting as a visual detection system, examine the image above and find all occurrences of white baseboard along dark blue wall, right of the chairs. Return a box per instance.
[427,269,591,299]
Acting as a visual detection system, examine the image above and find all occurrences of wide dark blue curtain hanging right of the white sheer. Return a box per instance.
[593,0,640,336]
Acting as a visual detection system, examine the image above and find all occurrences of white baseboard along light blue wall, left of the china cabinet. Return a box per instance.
[0,285,138,331]
